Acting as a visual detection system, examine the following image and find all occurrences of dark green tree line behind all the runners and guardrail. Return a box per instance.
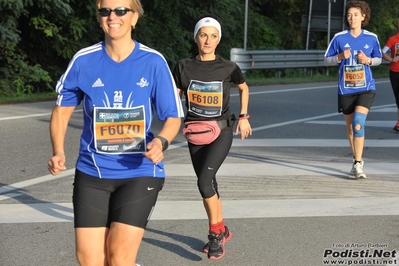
[0,0,399,96]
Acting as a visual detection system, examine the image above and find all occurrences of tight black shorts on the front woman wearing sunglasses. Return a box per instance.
[73,170,165,229]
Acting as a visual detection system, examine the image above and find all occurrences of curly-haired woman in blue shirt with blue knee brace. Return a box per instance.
[325,1,382,179]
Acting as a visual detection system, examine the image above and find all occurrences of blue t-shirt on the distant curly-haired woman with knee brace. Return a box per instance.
[325,30,382,95]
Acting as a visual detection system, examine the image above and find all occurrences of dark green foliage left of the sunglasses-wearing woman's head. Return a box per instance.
[0,0,101,96]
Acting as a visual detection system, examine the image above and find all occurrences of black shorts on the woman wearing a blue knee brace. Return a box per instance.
[338,91,375,115]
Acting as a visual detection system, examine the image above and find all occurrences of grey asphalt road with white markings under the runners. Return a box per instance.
[0,79,399,266]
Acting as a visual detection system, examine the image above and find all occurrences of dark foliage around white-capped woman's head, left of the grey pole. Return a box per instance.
[134,0,244,65]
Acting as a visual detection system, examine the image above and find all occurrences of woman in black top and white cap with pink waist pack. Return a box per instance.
[173,15,252,259]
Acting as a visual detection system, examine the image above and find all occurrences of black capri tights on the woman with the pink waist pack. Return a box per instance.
[188,127,233,199]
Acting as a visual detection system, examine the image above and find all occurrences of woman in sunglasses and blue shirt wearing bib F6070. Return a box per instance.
[48,0,184,265]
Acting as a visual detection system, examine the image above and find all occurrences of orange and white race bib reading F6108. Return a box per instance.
[187,80,223,117]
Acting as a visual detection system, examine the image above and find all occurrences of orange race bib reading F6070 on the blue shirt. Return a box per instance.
[94,106,146,154]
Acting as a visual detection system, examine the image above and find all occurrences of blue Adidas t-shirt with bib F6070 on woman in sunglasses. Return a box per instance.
[56,41,184,179]
